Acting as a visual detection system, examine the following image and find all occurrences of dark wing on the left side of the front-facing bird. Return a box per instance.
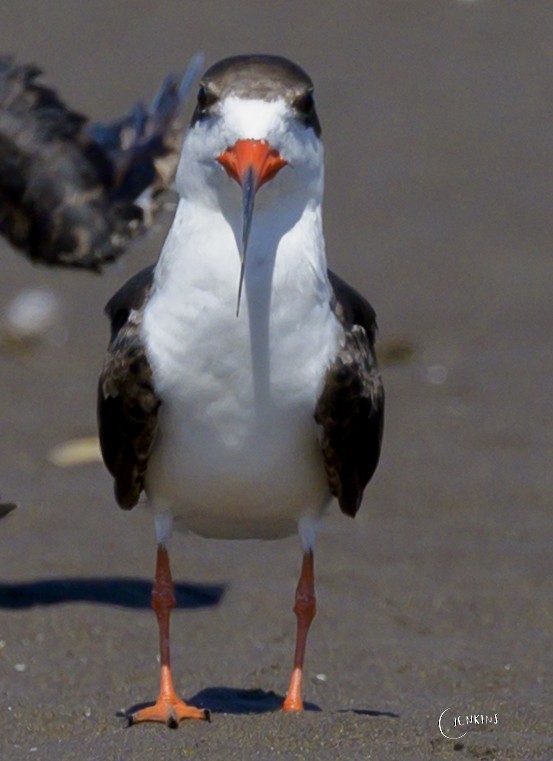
[98,267,157,510]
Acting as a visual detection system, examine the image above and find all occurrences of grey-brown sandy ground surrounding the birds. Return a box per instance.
[0,0,553,761]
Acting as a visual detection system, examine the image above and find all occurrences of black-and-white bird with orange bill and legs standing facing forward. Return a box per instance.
[98,54,384,727]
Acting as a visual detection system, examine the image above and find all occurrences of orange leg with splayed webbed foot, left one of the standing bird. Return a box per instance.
[130,544,209,728]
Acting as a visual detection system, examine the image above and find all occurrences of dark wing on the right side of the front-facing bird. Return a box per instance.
[315,270,384,517]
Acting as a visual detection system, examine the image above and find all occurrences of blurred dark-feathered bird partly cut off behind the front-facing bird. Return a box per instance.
[0,54,203,271]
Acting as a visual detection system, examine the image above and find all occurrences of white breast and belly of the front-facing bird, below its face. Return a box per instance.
[143,201,343,538]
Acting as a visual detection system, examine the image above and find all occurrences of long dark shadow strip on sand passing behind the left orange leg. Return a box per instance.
[0,577,225,610]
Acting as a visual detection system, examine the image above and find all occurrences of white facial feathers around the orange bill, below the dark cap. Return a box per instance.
[176,96,324,213]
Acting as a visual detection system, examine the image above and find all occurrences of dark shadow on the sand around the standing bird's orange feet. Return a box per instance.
[122,687,321,719]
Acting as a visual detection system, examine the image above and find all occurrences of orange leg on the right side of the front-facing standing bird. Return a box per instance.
[282,551,317,711]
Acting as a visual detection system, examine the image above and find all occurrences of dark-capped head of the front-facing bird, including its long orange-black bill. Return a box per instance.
[176,55,324,307]
